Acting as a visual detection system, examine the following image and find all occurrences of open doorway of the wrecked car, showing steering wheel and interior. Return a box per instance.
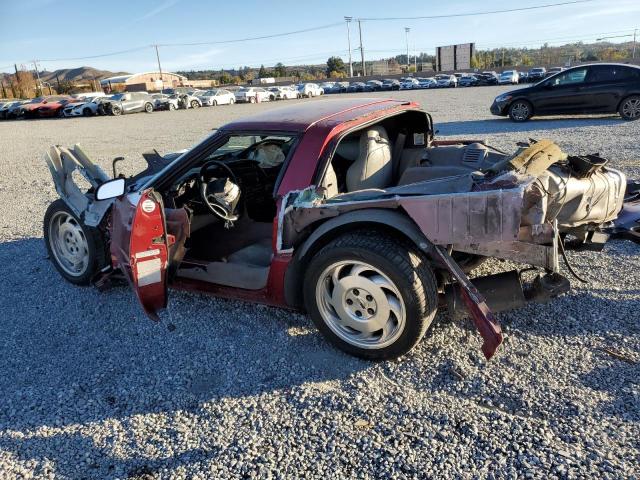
[164,135,295,290]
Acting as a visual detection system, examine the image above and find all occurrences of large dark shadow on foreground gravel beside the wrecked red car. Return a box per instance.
[0,238,371,478]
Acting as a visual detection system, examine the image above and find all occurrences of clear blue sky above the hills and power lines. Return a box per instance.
[0,0,640,72]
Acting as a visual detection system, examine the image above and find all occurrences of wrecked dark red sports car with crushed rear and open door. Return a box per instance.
[44,98,626,359]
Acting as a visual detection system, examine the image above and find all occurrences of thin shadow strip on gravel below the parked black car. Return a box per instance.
[436,117,627,138]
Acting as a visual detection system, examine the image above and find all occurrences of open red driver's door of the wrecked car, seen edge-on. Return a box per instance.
[111,189,169,320]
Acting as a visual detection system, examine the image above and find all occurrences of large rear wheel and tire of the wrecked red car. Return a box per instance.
[304,231,438,360]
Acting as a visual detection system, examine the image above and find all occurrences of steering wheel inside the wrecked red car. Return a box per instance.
[198,160,240,228]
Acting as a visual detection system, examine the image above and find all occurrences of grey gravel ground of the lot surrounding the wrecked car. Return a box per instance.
[0,87,640,479]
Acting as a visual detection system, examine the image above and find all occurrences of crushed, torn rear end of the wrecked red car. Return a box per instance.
[278,140,626,359]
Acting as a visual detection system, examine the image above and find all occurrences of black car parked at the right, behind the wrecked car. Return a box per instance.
[491,63,640,122]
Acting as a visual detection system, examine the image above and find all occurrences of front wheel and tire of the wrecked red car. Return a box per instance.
[43,199,108,285]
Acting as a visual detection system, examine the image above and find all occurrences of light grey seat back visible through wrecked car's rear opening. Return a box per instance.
[346,126,393,192]
